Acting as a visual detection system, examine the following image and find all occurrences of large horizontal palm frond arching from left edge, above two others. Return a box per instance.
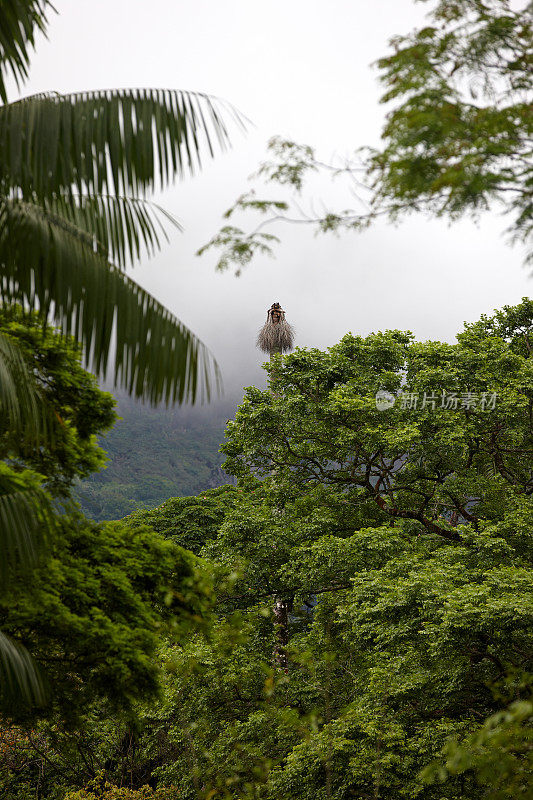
[0,89,244,199]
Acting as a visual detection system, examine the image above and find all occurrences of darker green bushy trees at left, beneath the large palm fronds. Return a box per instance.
[0,316,212,740]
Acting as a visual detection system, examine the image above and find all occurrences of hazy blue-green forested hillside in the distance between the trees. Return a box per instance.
[74,395,235,520]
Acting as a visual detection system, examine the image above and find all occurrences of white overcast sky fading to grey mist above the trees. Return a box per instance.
[13,0,531,397]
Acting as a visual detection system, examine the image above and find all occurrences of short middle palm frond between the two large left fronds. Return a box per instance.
[42,193,182,267]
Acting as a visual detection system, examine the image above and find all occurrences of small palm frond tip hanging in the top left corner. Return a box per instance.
[0,0,54,103]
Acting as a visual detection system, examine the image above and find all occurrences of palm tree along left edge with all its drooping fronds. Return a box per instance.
[0,0,241,700]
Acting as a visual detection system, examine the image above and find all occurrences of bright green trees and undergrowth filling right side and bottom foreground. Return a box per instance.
[3,301,533,800]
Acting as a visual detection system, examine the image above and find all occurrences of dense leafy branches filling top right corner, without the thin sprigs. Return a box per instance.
[370,0,533,256]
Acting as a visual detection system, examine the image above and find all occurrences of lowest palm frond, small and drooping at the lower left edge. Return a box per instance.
[0,631,46,709]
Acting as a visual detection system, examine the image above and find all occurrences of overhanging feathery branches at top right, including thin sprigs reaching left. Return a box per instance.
[200,0,533,270]
